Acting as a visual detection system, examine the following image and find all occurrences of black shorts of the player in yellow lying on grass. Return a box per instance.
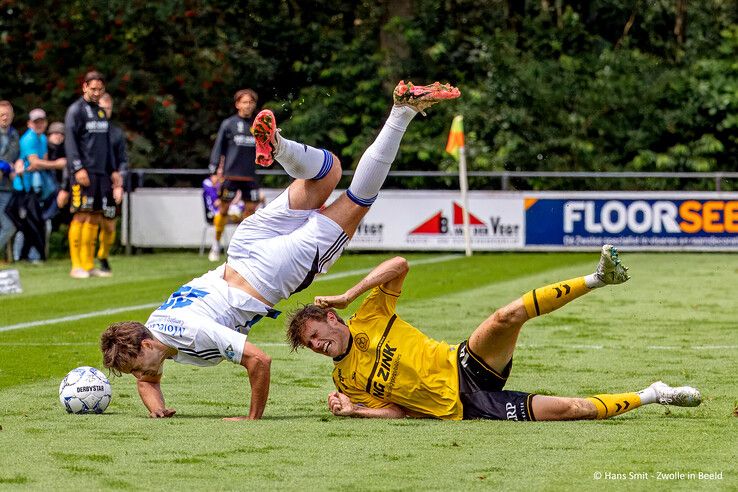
[457,341,536,420]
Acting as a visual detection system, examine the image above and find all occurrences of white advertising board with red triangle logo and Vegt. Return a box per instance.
[122,188,525,251]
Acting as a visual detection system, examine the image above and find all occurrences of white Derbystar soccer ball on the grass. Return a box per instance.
[59,366,113,413]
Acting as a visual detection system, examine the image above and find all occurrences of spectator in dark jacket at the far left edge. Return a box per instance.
[0,100,20,262]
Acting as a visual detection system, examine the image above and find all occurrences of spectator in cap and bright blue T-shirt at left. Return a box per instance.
[13,108,67,262]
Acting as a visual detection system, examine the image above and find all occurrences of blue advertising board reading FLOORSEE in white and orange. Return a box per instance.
[525,193,738,251]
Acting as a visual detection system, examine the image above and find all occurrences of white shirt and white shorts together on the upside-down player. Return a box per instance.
[146,192,349,366]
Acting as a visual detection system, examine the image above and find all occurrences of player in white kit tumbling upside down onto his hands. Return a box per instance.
[100,82,460,420]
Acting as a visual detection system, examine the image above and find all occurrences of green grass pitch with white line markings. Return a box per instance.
[0,252,738,490]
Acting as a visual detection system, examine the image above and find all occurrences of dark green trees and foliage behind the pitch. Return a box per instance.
[0,0,738,188]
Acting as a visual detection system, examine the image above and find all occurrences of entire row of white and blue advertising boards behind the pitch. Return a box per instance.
[122,188,738,251]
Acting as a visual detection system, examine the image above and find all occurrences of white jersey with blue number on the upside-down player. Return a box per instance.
[146,265,279,366]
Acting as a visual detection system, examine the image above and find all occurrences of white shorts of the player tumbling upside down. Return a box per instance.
[228,191,349,304]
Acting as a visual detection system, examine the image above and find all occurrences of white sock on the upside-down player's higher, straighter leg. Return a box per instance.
[346,106,418,207]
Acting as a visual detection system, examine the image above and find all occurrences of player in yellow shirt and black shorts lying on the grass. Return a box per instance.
[287,245,702,420]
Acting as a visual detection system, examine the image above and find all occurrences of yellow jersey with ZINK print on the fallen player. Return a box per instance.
[333,287,463,420]
